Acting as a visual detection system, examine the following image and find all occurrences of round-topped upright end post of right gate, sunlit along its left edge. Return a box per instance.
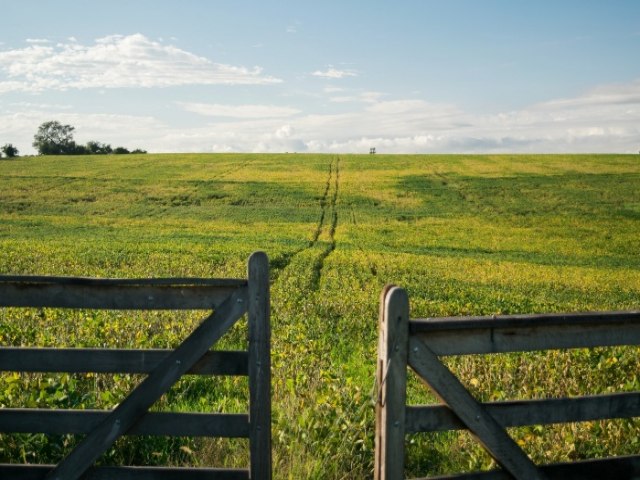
[374,286,409,480]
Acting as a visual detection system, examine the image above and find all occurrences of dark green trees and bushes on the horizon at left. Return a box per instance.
[0,120,147,158]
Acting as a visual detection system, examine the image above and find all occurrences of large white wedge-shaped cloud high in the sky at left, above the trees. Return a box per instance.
[0,34,281,93]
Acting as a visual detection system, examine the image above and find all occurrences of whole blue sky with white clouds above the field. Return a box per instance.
[0,0,640,154]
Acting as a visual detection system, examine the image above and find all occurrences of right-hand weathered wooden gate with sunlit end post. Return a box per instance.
[375,287,640,480]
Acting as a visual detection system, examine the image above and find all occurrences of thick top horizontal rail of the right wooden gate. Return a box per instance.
[409,311,640,355]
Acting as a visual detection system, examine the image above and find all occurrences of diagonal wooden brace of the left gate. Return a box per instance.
[46,287,248,480]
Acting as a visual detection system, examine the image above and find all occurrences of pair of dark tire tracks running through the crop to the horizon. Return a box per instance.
[271,157,340,291]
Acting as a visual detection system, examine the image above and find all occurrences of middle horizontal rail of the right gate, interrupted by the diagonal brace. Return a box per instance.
[405,392,640,433]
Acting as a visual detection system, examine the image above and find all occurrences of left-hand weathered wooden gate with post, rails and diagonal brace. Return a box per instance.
[0,252,271,480]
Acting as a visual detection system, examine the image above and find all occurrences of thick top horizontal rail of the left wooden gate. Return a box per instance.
[0,277,246,310]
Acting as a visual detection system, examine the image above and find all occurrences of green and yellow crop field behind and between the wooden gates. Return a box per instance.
[0,154,640,479]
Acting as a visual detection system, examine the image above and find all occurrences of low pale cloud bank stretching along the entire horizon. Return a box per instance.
[5,81,640,153]
